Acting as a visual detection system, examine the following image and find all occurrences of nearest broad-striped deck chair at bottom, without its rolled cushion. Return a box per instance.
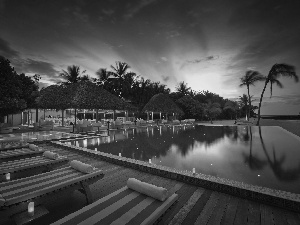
[51,178,178,225]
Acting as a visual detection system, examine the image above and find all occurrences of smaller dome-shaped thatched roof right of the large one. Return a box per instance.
[142,93,184,114]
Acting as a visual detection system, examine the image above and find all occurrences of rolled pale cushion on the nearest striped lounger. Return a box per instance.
[127,178,168,201]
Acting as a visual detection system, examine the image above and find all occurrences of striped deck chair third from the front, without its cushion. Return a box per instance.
[0,156,68,181]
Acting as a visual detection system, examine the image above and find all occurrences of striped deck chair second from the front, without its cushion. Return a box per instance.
[0,166,104,211]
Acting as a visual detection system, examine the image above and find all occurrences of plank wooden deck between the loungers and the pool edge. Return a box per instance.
[0,144,300,225]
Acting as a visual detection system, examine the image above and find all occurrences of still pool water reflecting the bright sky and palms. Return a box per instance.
[64,126,300,194]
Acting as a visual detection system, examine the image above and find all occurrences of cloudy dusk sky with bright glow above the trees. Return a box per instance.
[0,0,300,115]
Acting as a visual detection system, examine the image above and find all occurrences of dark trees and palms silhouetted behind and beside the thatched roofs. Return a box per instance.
[0,56,298,123]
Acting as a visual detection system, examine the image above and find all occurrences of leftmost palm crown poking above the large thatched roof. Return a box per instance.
[60,65,89,85]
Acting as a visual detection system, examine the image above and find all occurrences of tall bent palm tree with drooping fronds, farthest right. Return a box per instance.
[256,63,299,126]
